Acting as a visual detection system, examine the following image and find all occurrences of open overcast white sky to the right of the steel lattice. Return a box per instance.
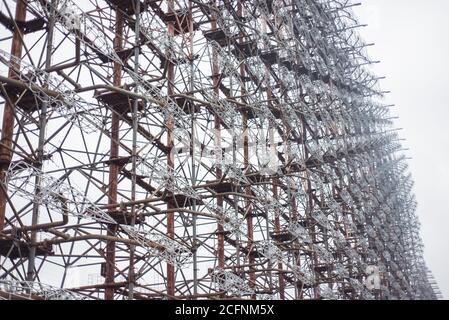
[353,0,449,299]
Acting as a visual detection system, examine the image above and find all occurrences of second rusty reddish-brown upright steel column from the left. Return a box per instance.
[105,9,124,300]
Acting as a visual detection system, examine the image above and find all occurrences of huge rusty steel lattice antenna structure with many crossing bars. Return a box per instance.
[0,0,437,299]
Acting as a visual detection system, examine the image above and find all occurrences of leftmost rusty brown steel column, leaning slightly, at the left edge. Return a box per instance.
[0,0,28,231]
